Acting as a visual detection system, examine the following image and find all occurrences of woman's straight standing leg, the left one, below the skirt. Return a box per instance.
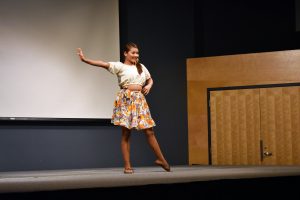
[121,127,133,173]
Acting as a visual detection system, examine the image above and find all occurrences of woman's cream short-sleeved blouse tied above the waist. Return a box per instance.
[107,62,151,88]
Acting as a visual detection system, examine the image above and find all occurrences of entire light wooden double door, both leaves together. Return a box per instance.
[210,86,300,165]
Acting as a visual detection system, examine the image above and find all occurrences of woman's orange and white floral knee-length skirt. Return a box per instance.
[111,89,155,130]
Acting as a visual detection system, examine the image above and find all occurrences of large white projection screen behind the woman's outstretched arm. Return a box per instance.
[0,0,120,120]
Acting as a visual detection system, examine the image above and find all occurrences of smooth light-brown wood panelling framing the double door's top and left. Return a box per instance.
[187,50,300,165]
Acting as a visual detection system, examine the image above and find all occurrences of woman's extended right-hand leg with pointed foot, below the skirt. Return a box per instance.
[144,128,170,171]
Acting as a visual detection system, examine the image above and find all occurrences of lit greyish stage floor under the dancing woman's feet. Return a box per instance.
[0,166,300,193]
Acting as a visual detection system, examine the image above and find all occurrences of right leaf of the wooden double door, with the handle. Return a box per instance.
[260,86,300,165]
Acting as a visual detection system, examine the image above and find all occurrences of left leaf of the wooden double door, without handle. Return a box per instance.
[210,89,260,165]
